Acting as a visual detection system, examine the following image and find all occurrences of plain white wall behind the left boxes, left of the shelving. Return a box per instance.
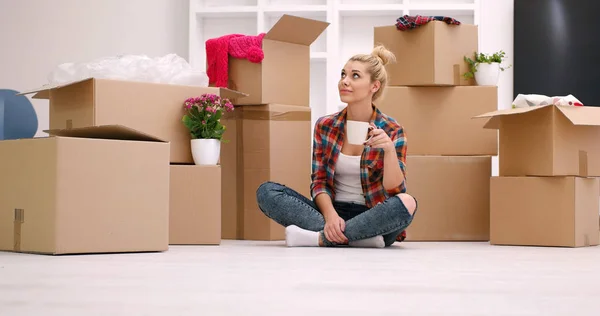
[0,0,189,136]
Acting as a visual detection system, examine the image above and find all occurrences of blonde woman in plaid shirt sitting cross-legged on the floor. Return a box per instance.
[256,46,417,248]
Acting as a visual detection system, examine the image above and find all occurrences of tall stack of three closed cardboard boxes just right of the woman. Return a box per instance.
[374,21,498,241]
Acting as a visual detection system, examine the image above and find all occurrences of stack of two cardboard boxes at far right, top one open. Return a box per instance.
[477,105,600,247]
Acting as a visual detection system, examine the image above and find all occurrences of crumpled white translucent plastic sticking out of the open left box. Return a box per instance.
[48,54,208,87]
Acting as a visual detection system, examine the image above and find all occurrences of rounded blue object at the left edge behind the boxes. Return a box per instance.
[0,89,38,140]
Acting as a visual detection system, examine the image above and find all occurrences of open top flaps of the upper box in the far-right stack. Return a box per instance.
[474,104,600,129]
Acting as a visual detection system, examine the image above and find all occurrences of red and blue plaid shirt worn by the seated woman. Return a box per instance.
[310,107,406,241]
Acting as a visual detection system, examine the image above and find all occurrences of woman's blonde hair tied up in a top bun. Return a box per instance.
[350,45,396,100]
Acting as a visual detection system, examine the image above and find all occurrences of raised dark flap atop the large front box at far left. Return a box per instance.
[44,125,166,142]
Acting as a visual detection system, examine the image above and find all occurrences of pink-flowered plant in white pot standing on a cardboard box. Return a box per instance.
[182,94,233,165]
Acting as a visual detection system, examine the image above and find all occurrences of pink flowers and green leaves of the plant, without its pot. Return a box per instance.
[181,94,233,141]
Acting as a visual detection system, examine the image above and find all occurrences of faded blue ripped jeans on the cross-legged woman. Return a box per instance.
[256,182,416,247]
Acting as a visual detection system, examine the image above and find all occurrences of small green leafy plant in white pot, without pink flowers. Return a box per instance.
[463,51,511,86]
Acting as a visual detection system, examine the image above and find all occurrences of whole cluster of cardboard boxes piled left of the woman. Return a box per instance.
[0,15,328,254]
